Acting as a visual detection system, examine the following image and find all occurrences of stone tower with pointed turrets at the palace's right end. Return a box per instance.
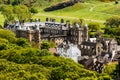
[70,23,88,45]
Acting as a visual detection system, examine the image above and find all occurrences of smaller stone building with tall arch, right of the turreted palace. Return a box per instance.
[79,37,118,56]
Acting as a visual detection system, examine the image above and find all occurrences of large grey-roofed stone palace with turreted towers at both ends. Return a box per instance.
[7,18,88,45]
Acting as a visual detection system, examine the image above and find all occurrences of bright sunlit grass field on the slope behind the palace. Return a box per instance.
[0,0,120,25]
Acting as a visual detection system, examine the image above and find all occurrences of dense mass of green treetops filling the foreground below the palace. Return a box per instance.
[0,30,115,80]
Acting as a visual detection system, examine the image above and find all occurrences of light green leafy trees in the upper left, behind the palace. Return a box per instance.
[1,4,32,22]
